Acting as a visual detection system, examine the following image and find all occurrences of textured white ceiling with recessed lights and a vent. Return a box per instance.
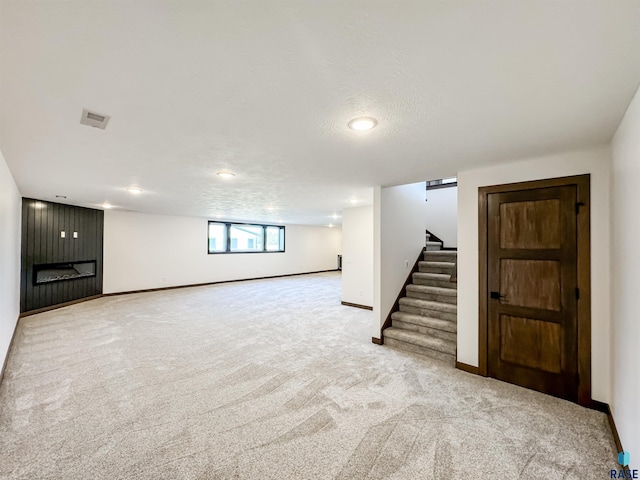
[0,0,640,224]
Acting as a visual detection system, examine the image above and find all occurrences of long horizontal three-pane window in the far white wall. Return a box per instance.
[208,221,284,253]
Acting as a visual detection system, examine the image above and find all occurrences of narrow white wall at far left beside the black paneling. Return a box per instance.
[0,152,22,368]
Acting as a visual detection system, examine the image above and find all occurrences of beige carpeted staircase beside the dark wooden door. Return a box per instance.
[383,242,458,365]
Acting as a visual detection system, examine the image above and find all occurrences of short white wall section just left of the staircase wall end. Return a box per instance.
[342,205,373,307]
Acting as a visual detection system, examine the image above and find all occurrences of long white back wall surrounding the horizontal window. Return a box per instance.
[103,211,342,293]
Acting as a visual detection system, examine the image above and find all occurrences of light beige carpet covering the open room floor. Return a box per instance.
[0,273,616,480]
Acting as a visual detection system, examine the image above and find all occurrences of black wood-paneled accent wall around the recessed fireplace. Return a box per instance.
[20,198,104,312]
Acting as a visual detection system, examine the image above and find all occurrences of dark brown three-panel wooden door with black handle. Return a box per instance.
[487,185,578,401]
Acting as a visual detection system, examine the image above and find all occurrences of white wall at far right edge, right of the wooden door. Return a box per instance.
[611,85,640,468]
